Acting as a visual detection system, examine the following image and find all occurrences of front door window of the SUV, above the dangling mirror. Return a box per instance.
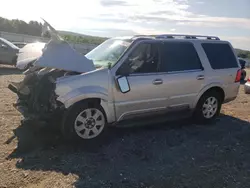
[127,43,159,74]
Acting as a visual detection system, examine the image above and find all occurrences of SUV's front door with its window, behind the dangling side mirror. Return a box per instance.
[113,42,166,121]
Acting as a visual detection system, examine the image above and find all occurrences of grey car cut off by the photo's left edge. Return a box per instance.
[0,38,19,65]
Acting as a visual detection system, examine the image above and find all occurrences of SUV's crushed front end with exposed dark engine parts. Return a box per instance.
[8,68,77,121]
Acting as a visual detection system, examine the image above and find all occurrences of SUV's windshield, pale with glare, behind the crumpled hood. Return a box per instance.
[85,39,132,67]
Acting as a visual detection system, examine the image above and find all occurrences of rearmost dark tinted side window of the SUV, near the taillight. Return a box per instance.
[202,43,238,69]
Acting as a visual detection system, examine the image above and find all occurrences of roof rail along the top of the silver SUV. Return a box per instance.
[155,34,220,40]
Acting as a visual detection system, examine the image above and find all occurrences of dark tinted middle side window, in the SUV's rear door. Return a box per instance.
[160,42,202,72]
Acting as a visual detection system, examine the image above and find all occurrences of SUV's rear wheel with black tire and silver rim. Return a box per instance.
[194,91,222,123]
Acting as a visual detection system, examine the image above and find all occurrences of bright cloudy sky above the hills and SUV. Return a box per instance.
[0,0,250,50]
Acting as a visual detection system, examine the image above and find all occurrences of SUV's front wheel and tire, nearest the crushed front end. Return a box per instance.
[61,103,107,141]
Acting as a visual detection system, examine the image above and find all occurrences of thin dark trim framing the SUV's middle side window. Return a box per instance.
[158,41,204,74]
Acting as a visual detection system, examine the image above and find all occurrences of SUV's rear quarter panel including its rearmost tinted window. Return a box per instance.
[201,41,240,100]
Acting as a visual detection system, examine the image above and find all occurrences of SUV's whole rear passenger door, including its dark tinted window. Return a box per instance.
[159,40,206,110]
